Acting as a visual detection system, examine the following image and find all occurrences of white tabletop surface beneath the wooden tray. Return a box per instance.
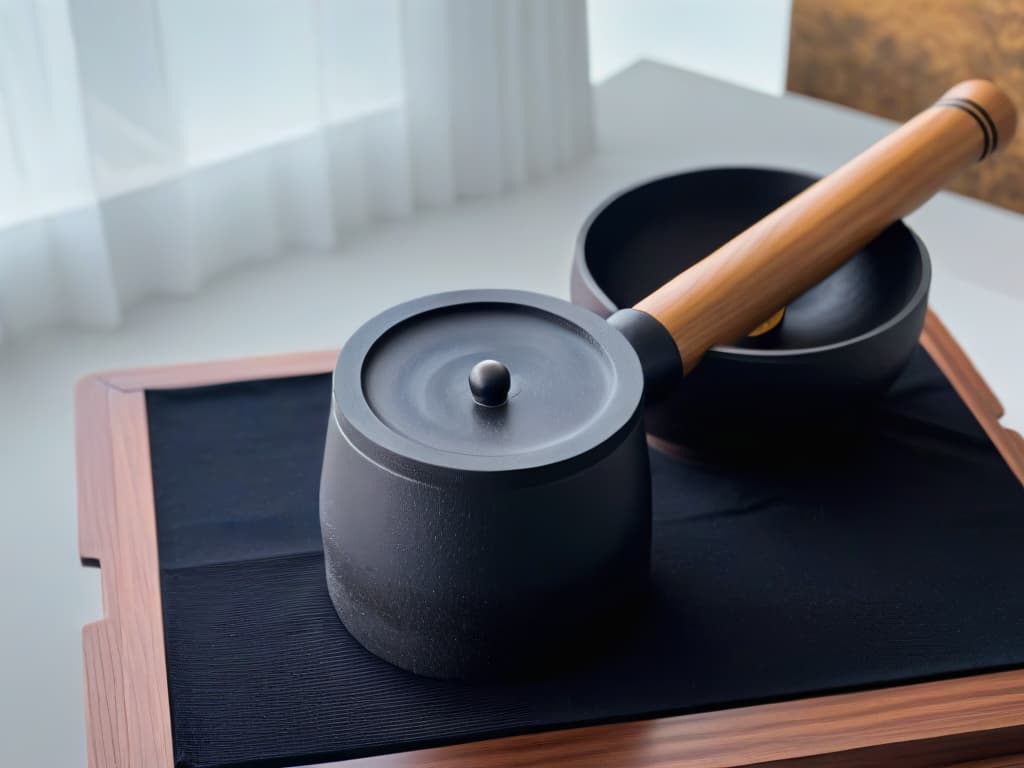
[0,63,1024,767]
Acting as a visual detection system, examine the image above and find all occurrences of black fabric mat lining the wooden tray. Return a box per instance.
[146,350,1024,766]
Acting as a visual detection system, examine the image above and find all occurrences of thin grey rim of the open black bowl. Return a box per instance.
[572,165,932,361]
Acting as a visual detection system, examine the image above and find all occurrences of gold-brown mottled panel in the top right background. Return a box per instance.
[788,0,1024,212]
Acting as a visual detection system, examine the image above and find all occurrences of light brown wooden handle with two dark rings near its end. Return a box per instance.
[634,80,1017,373]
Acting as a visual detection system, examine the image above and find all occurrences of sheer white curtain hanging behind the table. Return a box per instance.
[0,0,593,341]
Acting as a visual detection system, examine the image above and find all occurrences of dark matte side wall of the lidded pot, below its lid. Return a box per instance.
[321,410,650,679]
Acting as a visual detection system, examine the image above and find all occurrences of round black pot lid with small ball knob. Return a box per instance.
[334,291,643,479]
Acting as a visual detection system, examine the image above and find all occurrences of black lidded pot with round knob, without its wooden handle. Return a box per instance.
[321,291,650,679]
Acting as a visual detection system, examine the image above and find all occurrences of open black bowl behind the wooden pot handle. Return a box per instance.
[571,168,931,452]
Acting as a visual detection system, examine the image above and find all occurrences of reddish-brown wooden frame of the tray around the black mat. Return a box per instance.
[76,312,1024,768]
